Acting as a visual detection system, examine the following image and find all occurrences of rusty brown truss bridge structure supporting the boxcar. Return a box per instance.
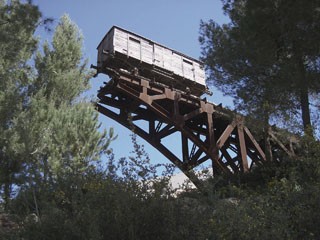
[96,70,276,188]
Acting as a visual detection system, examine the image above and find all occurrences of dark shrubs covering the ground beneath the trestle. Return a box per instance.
[10,131,320,239]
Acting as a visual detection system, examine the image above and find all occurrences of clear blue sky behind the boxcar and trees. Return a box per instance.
[34,0,231,167]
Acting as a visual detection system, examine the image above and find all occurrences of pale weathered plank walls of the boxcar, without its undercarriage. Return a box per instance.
[98,28,206,92]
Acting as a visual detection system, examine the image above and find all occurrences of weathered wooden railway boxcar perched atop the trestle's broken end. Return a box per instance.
[97,26,207,96]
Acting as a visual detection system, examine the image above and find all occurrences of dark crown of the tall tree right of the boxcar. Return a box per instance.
[200,0,320,132]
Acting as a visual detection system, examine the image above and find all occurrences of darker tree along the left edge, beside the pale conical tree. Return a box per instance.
[0,0,41,208]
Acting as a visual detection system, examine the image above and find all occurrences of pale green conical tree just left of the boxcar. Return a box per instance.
[11,13,114,219]
